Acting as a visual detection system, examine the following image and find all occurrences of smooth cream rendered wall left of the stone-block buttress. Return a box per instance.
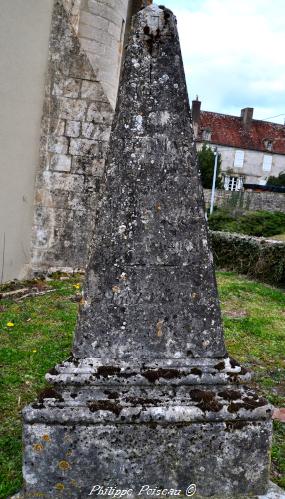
[0,0,53,281]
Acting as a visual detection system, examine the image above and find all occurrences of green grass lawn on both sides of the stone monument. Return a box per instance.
[0,272,285,499]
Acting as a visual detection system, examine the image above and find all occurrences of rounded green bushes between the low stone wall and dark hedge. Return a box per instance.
[209,209,285,237]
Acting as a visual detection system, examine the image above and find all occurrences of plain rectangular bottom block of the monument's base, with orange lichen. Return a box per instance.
[21,420,270,499]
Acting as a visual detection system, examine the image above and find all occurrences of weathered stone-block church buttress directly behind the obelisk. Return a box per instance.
[32,0,135,273]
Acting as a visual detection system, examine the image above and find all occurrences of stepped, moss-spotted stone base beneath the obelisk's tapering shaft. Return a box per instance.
[18,359,272,499]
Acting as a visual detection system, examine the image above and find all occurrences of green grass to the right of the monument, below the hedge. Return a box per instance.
[218,272,285,488]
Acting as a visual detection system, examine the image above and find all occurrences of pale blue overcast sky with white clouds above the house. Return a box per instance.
[162,0,285,123]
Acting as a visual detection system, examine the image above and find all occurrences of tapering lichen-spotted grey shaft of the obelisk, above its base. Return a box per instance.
[74,5,225,363]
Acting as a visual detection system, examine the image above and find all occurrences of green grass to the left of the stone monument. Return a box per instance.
[0,277,78,498]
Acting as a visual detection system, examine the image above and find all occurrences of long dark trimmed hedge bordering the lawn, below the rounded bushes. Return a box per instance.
[210,231,285,286]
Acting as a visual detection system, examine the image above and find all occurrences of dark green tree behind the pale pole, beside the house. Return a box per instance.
[198,144,222,189]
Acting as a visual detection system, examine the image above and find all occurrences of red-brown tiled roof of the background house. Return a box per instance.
[197,111,285,154]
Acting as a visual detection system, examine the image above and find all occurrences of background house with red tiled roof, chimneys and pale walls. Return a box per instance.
[192,98,285,191]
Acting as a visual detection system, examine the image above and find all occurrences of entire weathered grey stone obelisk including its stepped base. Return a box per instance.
[21,6,271,498]
